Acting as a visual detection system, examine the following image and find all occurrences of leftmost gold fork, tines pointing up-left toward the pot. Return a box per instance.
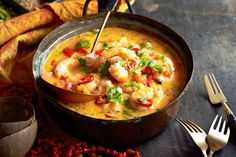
[176,118,208,157]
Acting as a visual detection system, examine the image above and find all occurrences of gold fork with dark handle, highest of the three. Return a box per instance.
[204,74,236,133]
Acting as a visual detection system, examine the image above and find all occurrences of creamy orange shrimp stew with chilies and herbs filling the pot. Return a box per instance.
[42,27,186,120]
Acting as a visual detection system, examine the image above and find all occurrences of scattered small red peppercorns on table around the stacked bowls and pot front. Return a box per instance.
[0,82,141,157]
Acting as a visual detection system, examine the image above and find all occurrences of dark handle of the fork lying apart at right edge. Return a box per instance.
[222,102,236,133]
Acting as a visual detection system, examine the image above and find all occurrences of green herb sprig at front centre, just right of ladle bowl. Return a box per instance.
[107,87,123,102]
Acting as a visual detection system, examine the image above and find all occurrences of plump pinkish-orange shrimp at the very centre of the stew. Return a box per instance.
[109,62,129,82]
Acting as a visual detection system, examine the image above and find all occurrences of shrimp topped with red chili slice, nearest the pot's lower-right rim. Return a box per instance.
[130,86,155,111]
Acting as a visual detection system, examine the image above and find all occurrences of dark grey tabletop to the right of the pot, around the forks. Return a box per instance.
[130,0,236,157]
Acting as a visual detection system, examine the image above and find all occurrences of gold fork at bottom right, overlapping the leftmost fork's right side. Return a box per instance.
[207,115,230,157]
